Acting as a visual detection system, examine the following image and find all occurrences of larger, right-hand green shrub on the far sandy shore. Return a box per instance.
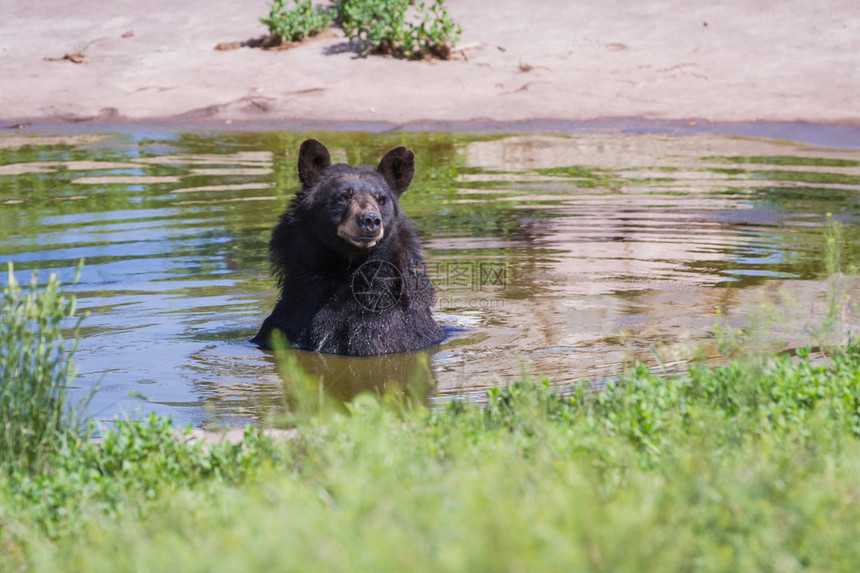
[338,0,462,60]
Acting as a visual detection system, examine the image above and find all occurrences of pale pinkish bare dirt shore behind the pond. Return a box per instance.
[0,0,860,130]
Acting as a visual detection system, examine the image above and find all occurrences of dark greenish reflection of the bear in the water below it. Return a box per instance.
[284,349,436,404]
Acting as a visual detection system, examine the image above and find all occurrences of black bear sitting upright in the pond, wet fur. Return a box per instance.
[252,139,444,356]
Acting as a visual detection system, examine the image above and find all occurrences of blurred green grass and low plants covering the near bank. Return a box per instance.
[0,262,860,572]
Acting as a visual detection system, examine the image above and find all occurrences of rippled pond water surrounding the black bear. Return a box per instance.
[0,131,860,427]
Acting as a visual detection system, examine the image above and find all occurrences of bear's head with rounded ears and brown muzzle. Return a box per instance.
[299,139,415,255]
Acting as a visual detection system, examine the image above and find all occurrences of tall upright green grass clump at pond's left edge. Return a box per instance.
[0,262,85,471]
